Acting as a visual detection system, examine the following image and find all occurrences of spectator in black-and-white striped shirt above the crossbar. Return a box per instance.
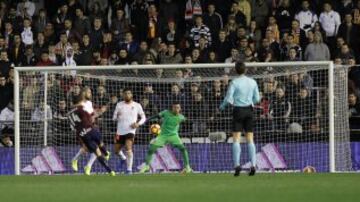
[190,16,212,47]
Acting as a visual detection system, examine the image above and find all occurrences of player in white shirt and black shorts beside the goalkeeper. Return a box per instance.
[113,89,146,174]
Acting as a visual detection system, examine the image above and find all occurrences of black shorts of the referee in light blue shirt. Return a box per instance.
[233,106,254,133]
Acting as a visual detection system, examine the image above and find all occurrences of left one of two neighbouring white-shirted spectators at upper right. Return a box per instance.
[295,0,318,32]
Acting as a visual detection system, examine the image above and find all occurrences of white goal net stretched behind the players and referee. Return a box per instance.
[14,62,352,174]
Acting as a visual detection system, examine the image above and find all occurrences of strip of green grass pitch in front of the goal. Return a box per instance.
[0,173,360,202]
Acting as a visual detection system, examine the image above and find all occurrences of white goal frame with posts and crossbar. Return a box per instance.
[14,61,336,175]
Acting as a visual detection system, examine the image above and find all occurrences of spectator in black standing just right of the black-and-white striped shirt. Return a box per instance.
[204,3,223,39]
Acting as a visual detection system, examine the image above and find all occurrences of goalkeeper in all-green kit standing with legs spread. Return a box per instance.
[140,102,192,173]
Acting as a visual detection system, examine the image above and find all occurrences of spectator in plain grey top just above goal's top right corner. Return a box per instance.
[304,32,330,61]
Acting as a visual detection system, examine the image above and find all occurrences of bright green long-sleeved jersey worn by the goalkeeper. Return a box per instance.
[159,110,185,136]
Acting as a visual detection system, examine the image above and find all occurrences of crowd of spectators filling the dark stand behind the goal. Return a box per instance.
[0,0,360,145]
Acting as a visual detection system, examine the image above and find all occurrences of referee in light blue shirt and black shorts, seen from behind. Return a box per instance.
[220,62,260,176]
